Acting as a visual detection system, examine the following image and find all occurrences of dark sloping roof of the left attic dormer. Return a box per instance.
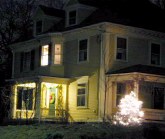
[39,5,65,18]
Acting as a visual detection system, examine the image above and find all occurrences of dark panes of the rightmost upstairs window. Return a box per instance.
[151,43,160,65]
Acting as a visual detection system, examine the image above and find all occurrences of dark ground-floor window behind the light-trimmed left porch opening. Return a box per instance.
[17,87,34,110]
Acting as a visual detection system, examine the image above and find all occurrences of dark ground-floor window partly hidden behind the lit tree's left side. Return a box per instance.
[116,83,126,106]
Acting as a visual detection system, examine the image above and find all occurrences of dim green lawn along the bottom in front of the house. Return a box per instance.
[0,123,165,139]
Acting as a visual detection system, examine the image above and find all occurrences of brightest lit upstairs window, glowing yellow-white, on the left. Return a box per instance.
[41,45,49,66]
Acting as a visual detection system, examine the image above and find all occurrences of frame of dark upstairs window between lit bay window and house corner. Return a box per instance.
[77,38,89,63]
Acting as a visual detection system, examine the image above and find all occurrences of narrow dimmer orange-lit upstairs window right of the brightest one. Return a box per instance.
[54,44,61,64]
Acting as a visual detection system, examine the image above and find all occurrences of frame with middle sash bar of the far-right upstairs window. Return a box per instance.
[149,42,161,66]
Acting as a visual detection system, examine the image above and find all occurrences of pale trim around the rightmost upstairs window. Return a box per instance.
[149,41,162,66]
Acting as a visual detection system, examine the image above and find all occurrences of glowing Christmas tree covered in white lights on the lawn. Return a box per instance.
[114,91,144,126]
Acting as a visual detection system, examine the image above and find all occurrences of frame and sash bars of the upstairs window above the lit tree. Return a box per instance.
[115,36,128,62]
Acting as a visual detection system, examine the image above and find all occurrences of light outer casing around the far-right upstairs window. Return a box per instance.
[148,41,162,67]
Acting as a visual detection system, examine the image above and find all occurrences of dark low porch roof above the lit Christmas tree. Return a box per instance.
[107,64,165,75]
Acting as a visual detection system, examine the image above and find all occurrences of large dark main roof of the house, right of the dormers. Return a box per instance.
[65,0,165,32]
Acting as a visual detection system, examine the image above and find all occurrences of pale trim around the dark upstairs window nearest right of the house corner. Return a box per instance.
[114,35,128,62]
